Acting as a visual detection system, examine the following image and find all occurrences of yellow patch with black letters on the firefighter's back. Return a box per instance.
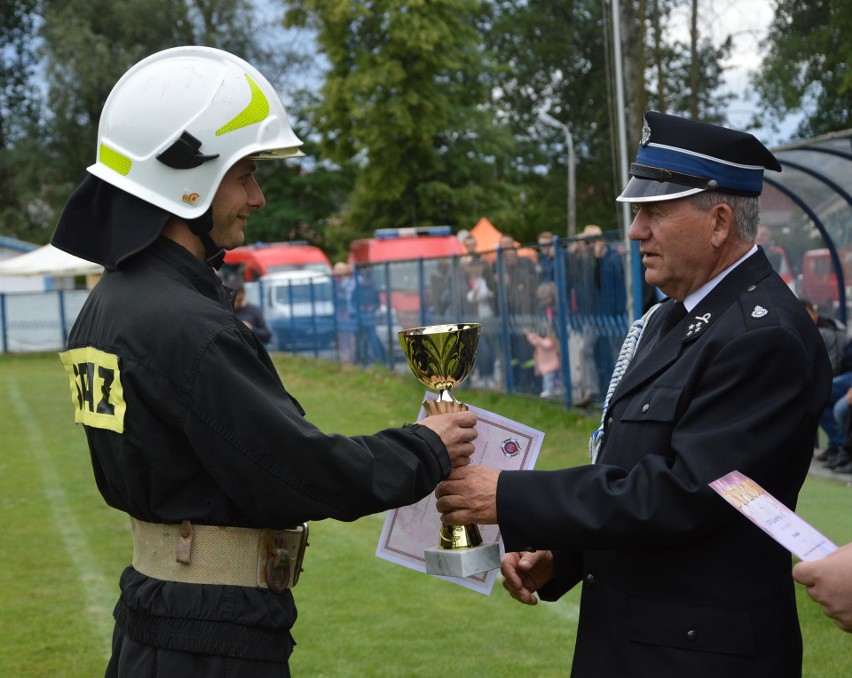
[59,346,127,433]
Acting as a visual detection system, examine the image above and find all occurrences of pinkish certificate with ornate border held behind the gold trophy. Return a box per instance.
[376,393,544,595]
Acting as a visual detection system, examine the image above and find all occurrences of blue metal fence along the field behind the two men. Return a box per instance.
[0,238,628,406]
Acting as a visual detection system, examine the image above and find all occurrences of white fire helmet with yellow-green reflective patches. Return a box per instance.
[88,47,304,219]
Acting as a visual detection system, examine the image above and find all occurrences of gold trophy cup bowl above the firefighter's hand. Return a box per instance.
[399,323,480,415]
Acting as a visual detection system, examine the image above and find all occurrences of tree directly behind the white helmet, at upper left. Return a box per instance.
[37,0,266,199]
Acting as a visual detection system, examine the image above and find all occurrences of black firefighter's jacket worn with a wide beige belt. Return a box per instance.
[61,238,451,661]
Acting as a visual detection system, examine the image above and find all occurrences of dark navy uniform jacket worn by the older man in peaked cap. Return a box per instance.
[497,250,831,678]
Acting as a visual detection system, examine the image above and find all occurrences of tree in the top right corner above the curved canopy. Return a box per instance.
[752,0,852,138]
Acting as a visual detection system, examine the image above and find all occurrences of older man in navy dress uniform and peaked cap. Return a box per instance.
[436,112,831,678]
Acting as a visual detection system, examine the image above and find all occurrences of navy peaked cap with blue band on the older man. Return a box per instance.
[617,111,781,202]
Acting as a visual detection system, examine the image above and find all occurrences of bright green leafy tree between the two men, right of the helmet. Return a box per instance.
[287,0,511,235]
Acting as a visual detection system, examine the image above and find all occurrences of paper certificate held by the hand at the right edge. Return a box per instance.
[710,471,837,560]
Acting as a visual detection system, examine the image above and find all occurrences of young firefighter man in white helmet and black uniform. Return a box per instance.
[53,47,476,678]
